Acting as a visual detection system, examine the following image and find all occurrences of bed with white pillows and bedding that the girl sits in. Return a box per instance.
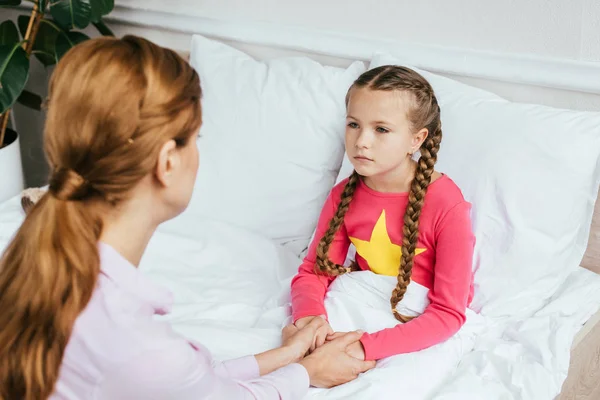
[0,2,600,400]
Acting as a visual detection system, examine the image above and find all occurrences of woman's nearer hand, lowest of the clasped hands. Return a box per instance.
[300,332,375,388]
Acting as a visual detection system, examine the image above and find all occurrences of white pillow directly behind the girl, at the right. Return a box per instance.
[337,54,600,316]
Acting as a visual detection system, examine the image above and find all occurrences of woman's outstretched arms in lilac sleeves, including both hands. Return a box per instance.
[94,320,375,400]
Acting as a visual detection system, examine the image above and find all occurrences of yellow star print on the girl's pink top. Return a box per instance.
[350,210,427,276]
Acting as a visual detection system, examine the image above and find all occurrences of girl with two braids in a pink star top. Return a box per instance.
[292,66,475,360]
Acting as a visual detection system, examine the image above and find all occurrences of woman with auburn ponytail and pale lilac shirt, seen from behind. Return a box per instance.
[0,36,374,400]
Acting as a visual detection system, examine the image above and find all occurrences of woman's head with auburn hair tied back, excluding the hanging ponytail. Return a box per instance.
[44,36,201,219]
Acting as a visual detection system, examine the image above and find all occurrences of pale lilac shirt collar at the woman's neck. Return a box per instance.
[99,242,173,315]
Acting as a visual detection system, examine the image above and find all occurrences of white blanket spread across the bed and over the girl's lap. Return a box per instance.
[0,199,600,400]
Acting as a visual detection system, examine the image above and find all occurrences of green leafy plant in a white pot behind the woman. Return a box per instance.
[0,0,114,201]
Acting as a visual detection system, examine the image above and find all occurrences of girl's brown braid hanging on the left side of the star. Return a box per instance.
[315,171,360,276]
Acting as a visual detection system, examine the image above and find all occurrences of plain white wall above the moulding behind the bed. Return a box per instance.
[116,0,600,61]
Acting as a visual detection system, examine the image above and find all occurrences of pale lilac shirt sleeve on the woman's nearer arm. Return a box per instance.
[95,340,309,400]
